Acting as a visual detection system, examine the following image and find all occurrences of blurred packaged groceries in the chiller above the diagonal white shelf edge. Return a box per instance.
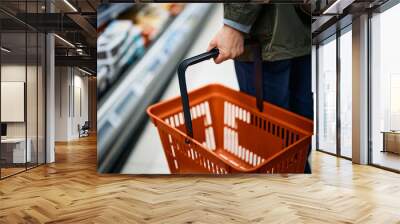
[97,3,185,96]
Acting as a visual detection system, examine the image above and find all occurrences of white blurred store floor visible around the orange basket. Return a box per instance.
[121,4,238,174]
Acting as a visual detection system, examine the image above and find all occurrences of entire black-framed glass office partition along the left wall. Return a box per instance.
[0,1,46,178]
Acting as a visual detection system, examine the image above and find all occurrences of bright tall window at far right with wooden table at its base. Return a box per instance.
[370,4,400,171]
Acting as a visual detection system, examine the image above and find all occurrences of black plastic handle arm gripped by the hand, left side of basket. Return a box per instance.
[178,48,219,141]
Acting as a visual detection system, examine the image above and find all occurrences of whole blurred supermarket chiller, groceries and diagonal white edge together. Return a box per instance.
[97,3,223,172]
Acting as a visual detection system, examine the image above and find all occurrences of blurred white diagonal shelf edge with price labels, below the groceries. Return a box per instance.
[98,4,212,172]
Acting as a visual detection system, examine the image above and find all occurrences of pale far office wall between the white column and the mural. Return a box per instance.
[55,67,88,141]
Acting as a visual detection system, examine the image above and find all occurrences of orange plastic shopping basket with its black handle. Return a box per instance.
[147,49,313,174]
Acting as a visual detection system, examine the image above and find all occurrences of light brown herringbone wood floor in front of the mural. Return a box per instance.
[0,137,400,223]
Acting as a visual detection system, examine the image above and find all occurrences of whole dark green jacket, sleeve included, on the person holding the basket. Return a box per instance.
[224,3,311,61]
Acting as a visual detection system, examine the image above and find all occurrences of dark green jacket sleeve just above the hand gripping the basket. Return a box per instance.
[224,3,262,33]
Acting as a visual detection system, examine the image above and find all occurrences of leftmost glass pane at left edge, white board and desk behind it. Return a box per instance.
[0,32,27,177]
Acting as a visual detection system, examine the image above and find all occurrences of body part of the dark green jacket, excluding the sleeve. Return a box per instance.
[238,4,311,61]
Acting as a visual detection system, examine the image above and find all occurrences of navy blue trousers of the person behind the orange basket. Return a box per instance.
[235,55,314,173]
